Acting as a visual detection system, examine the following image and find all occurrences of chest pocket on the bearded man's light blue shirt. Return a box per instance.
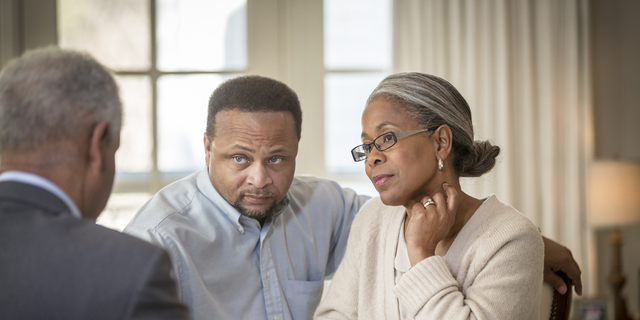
[283,280,324,320]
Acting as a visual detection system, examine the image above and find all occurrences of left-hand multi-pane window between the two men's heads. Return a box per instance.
[58,0,248,229]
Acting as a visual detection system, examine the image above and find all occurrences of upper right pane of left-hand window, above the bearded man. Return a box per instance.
[157,0,247,71]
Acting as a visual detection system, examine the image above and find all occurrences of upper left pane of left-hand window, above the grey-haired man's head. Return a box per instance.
[58,0,151,70]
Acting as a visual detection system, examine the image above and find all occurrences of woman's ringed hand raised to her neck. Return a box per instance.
[404,183,458,267]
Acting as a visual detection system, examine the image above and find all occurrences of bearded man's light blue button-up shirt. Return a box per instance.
[124,168,368,320]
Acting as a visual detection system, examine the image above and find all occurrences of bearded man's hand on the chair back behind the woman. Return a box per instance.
[542,237,582,295]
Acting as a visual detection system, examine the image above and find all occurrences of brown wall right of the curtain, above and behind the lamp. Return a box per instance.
[591,0,640,314]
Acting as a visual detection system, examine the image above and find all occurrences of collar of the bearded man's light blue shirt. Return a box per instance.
[196,167,290,234]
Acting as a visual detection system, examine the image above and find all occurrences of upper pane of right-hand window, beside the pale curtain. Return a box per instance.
[324,0,391,70]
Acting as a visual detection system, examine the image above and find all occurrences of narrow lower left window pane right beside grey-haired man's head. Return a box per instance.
[116,76,153,176]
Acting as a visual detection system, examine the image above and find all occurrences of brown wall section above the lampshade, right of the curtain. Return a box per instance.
[591,0,640,160]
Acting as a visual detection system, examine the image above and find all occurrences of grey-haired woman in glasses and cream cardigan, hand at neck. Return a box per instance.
[315,73,543,320]
